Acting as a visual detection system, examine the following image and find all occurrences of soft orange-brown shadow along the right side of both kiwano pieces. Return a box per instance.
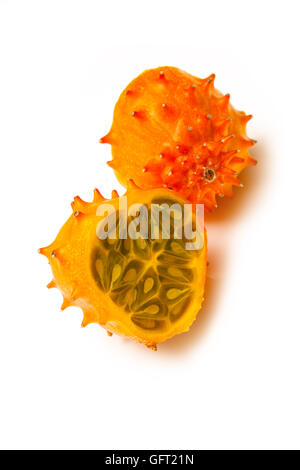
[158,139,268,356]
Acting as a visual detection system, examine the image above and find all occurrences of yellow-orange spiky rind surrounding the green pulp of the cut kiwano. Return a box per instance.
[39,184,207,350]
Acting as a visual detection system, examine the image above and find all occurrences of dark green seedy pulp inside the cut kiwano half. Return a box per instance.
[90,202,200,330]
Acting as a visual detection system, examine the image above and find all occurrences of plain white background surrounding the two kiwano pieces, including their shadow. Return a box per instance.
[0,0,300,449]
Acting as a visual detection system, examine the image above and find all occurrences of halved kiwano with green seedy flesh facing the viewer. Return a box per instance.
[39,184,206,349]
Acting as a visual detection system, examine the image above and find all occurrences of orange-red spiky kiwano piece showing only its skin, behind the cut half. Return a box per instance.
[100,67,256,210]
